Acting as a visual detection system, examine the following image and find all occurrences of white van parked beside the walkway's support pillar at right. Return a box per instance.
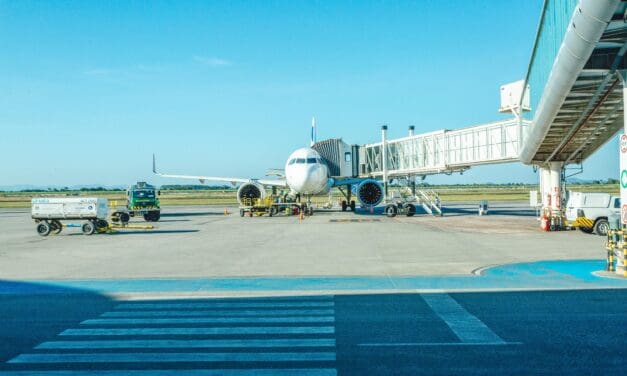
[566,192,620,236]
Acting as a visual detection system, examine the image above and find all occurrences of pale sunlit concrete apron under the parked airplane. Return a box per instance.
[0,203,605,280]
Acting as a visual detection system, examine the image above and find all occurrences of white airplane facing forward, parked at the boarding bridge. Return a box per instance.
[152,118,383,215]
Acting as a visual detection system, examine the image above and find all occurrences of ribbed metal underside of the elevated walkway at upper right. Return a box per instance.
[521,1,627,165]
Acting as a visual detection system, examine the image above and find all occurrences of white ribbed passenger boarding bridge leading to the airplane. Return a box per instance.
[359,119,530,178]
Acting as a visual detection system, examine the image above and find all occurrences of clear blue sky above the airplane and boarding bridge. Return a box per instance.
[0,0,618,186]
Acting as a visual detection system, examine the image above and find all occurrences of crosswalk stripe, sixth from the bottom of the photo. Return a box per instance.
[100,309,335,317]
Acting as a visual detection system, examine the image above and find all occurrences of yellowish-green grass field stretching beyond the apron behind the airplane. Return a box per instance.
[0,184,619,208]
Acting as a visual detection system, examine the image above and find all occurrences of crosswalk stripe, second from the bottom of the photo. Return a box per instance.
[8,352,335,364]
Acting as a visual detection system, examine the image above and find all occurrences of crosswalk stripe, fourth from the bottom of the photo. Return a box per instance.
[59,326,335,336]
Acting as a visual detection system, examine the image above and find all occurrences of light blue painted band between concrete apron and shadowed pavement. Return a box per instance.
[0,260,627,301]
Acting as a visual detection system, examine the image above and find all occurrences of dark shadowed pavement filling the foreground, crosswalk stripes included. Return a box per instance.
[0,281,627,375]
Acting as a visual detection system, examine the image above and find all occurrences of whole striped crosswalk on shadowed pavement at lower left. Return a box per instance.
[0,297,337,376]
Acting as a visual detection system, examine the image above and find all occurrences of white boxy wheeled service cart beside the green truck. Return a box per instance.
[31,197,109,236]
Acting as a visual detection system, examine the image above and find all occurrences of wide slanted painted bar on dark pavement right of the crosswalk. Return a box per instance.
[420,294,506,344]
